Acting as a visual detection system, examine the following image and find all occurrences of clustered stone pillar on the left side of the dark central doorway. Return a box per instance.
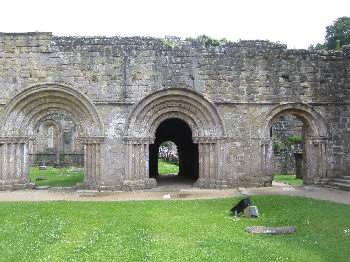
[123,137,157,190]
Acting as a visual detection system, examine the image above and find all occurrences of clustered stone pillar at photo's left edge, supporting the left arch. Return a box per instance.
[0,137,32,190]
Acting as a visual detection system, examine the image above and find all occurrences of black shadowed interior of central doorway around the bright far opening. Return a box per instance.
[149,118,199,185]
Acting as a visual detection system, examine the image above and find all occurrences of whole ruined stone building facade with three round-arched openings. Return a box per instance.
[0,32,350,190]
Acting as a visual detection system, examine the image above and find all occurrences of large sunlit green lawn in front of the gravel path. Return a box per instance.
[0,196,350,262]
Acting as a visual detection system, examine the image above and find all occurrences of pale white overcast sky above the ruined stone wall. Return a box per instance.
[0,0,350,48]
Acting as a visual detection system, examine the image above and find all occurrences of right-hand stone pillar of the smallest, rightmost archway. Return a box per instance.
[304,137,327,184]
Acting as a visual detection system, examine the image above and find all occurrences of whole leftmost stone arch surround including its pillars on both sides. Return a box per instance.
[0,83,104,189]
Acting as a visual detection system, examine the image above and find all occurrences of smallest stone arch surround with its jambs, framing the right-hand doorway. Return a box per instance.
[261,103,328,184]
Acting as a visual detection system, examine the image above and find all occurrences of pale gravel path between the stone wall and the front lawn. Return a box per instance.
[0,183,350,204]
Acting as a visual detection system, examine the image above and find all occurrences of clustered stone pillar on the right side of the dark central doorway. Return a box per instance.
[193,137,227,188]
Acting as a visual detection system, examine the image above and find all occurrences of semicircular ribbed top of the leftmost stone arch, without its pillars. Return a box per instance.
[1,83,104,136]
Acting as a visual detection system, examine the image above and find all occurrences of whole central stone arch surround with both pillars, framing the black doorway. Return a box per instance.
[123,88,225,189]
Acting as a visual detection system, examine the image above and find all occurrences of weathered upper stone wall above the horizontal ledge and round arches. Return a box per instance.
[0,32,350,104]
